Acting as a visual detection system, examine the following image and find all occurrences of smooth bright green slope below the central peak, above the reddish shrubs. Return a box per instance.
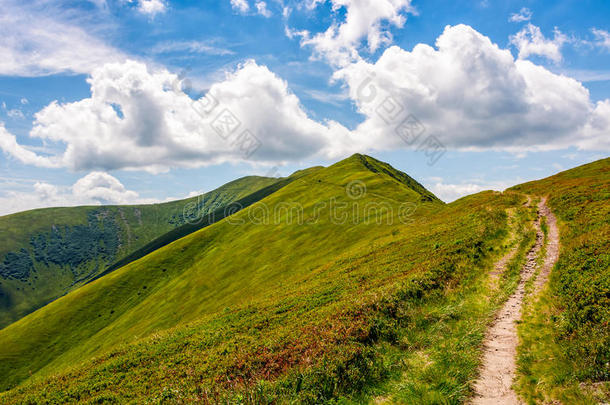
[0,158,440,388]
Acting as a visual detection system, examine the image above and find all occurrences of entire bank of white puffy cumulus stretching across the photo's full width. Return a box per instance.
[0,25,610,172]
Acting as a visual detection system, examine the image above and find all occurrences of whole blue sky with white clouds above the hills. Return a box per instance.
[0,0,610,215]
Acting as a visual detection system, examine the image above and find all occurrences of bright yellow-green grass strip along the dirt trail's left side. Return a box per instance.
[358,200,535,404]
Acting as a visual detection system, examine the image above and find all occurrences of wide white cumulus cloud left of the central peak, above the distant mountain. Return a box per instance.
[0,61,350,172]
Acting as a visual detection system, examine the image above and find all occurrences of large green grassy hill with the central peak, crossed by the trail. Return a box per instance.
[0,155,610,404]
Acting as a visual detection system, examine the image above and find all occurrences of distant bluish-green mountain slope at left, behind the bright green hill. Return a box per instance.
[0,176,278,328]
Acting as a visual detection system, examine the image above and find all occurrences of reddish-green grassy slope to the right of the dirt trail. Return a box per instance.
[514,159,610,403]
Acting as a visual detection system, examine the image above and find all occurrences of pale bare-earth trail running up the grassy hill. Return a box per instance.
[472,198,559,405]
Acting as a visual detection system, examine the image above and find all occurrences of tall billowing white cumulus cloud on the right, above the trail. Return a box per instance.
[335,25,610,151]
